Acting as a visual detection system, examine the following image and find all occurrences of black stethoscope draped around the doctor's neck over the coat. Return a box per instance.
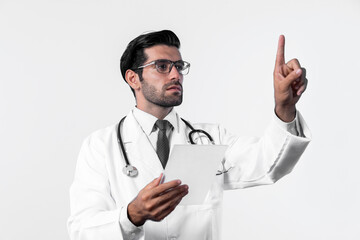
[117,116,228,177]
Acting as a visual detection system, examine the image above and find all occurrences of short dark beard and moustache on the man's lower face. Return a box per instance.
[141,79,183,108]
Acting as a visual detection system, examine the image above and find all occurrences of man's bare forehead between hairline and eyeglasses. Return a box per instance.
[144,45,181,62]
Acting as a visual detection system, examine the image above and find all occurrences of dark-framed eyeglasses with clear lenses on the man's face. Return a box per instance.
[137,59,190,75]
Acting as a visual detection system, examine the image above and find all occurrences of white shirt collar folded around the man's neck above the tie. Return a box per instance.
[133,107,179,136]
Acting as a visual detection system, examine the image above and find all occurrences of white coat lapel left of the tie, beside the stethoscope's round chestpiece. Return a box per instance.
[123,112,163,178]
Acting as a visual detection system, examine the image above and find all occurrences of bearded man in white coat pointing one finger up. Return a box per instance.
[68,30,310,240]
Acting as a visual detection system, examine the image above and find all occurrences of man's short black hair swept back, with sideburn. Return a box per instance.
[120,30,180,95]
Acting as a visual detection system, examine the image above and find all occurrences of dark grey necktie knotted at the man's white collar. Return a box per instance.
[155,120,171,169]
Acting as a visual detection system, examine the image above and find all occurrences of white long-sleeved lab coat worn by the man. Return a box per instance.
[68,109,310,240]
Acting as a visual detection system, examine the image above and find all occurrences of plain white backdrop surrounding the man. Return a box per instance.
[0,0,360,240]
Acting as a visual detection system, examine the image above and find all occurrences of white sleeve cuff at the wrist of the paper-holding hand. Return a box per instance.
[119,205,144,240]
